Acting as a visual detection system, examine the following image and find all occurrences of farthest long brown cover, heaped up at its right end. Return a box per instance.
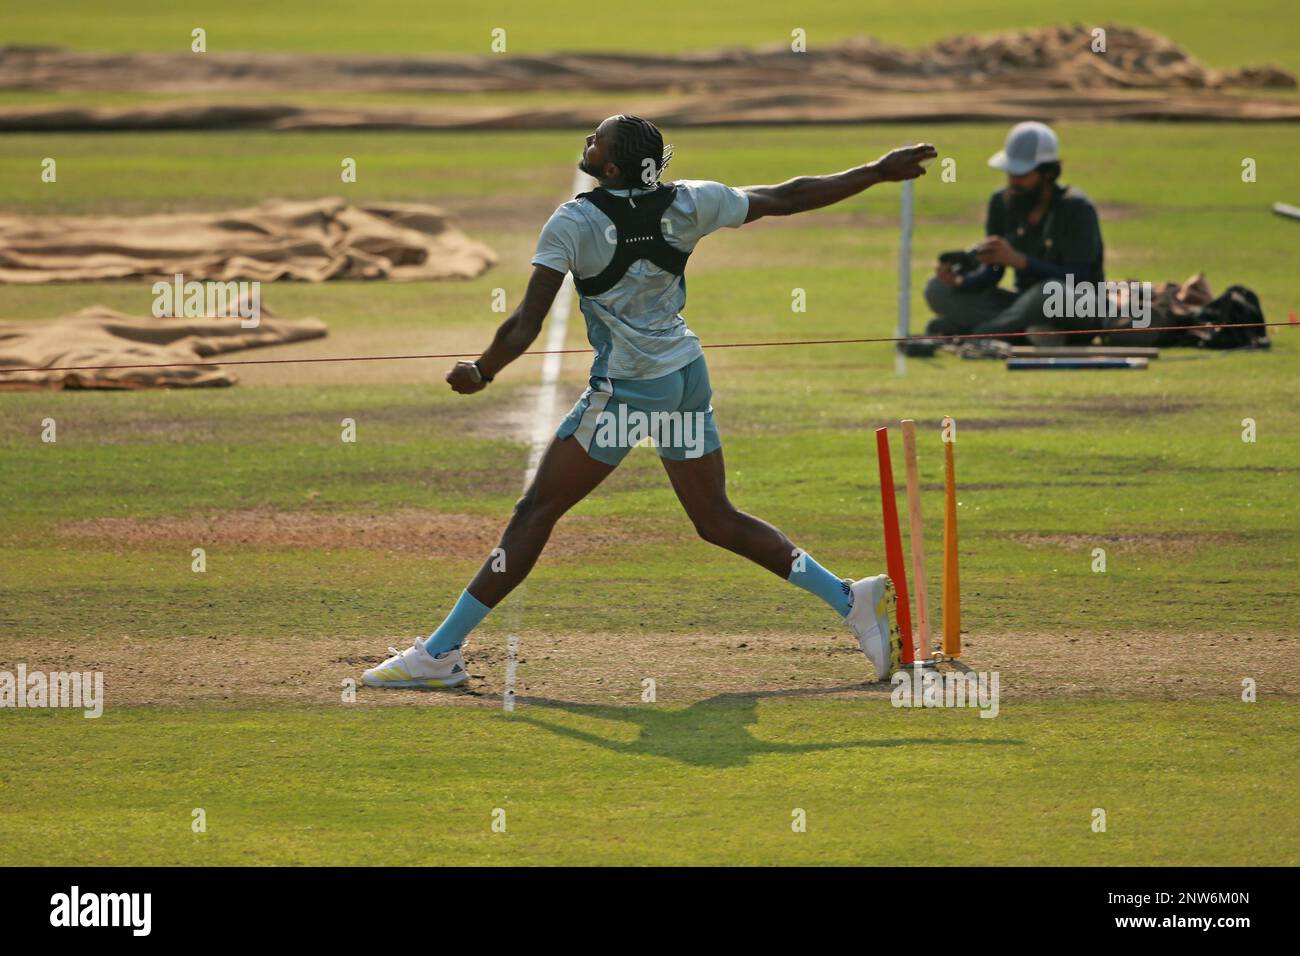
[0,26,1296,94]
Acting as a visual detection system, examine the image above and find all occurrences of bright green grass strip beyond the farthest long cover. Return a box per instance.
[0,0,1300,78]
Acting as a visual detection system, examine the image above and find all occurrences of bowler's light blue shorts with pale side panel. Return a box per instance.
[555,355,723,464]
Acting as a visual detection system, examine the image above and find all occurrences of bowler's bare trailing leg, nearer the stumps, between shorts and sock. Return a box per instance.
[660,449,794,580]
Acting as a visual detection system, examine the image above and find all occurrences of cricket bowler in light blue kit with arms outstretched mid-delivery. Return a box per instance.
[363,116,937,688]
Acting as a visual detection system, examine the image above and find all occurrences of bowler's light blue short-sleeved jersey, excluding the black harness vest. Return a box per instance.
[533,179,749,378]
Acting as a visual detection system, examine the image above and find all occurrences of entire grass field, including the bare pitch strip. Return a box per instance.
[0,3,1300,865]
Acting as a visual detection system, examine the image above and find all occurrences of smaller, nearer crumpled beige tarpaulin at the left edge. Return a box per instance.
[0,306,325,390]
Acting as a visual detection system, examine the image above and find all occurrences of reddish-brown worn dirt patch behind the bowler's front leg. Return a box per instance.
[57,509,654,558]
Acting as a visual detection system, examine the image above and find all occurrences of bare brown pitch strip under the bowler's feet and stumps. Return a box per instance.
[0,630,1300,709]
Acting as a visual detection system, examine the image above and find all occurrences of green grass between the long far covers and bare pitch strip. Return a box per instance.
[0,125,1300,636]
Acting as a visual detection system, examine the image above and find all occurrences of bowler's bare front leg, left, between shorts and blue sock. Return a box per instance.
[467,437,615,607]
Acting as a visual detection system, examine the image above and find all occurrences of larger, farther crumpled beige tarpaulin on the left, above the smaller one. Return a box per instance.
[0,199,497,284]
